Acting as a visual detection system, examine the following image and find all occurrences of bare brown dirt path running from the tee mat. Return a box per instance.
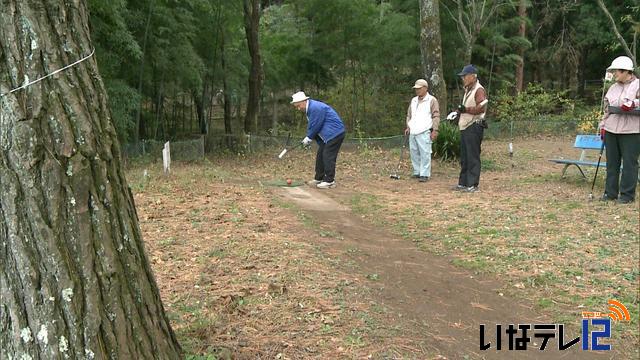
[274,186,613,359]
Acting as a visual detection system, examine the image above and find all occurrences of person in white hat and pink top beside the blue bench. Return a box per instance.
[599,56,640,204]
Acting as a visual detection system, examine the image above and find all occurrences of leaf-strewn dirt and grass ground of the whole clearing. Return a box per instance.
[128,138,640,359]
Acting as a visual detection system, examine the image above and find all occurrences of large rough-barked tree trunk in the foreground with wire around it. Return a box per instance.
[0,0,181,359]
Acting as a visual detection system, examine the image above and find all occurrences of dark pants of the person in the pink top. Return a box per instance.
[604,131,640,200]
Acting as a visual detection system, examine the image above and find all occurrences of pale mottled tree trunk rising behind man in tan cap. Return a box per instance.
[420,0,447,114]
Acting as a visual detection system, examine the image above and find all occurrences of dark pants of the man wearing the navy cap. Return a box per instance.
[458,123,484,187]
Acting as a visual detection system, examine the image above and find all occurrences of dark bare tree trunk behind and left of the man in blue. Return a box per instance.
[243,0,262,133]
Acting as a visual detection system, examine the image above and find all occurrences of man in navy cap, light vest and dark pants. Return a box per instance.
[455,64,489,192]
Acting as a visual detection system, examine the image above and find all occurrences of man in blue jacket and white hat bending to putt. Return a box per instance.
[291,91,345,189]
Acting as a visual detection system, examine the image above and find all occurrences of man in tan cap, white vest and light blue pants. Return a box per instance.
[404,79,440,182]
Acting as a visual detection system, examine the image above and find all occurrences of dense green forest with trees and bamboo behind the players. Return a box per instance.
[88,0,640,150]
